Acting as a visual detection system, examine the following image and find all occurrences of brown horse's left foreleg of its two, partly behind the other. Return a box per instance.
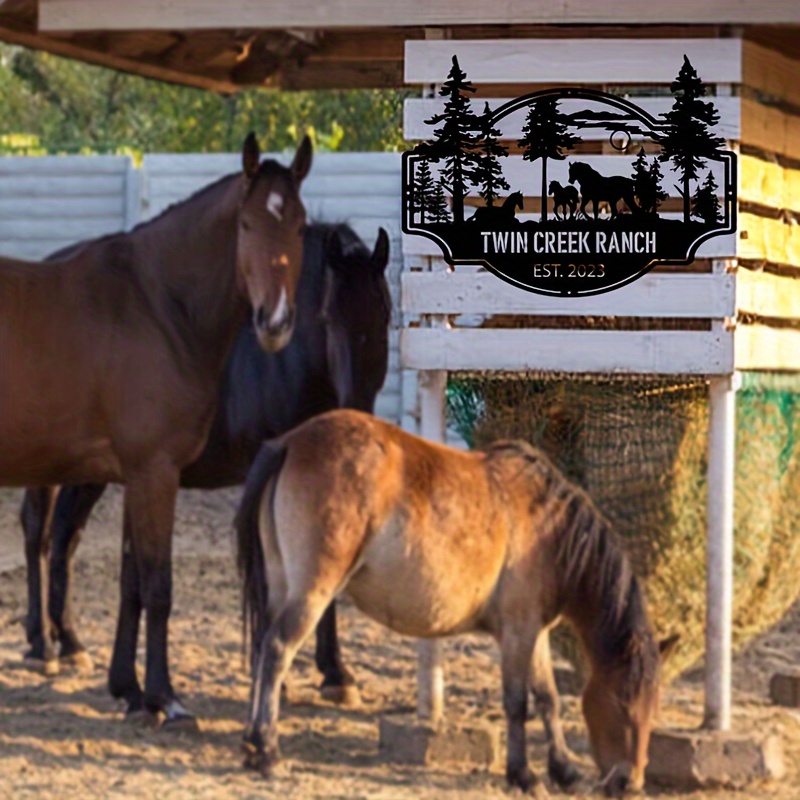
[108,505,145,718]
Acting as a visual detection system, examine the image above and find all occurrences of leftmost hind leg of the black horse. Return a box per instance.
[20,486,58,675]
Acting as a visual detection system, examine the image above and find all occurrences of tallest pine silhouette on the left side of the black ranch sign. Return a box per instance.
[424,56,481,223]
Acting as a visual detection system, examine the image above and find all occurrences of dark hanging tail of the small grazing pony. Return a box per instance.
[233,442,286,664]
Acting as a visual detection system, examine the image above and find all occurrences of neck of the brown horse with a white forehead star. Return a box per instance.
[128,174,247,371]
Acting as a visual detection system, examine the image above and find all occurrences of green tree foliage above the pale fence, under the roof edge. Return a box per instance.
[0,45,408,153]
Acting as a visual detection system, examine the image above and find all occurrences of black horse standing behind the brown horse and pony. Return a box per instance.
[21,224,391,702]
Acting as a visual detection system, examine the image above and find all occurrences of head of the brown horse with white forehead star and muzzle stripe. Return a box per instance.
[236,133,312,352]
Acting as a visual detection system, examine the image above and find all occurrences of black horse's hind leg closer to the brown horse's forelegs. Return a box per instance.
[50,484,106,671]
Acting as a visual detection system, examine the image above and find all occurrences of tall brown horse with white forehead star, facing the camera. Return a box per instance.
[0,134,311,725]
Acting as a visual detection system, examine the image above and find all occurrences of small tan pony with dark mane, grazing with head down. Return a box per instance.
[236,411,676,796]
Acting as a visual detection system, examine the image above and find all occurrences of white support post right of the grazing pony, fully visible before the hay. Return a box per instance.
[703,374,738,731]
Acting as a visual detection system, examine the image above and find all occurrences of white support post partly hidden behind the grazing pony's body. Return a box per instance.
[417,370,447,722]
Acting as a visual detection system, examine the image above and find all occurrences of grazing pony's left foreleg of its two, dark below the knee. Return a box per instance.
[500,626,543,795]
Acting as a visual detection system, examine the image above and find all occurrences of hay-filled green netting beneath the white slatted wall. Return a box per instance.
[448,373,800,675]
